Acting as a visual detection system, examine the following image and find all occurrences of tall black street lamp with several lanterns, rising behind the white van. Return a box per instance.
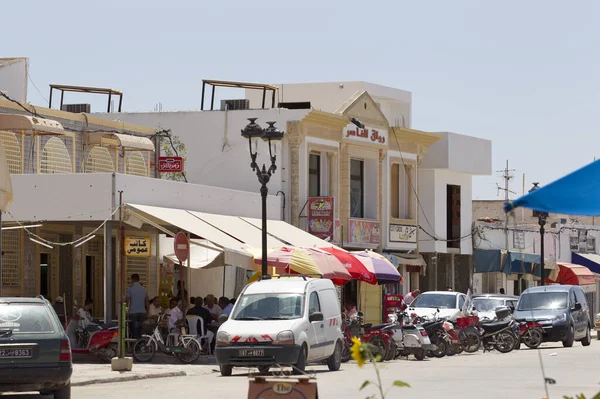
[242,118,283,278]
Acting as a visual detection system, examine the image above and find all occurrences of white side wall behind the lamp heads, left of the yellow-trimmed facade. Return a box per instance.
[94,109,308,195]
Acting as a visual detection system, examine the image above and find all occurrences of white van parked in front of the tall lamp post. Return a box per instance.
[216,277,344,376]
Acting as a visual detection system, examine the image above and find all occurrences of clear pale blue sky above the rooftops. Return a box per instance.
[0,0,600,199]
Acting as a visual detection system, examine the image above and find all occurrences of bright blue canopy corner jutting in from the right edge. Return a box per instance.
[504,160,600,216]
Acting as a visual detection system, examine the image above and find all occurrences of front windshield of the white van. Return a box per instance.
[231,293,304,320]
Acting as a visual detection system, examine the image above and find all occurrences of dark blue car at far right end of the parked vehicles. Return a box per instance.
[514,285,592,347]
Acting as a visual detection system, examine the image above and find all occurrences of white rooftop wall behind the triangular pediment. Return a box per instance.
[246,82,412,127]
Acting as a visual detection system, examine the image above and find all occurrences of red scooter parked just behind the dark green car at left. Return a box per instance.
[65,313,119,362]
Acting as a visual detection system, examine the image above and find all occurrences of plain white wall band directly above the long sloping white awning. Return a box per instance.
[3,173,281,221]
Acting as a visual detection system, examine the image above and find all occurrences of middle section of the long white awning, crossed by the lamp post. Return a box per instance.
[190,211,288,248]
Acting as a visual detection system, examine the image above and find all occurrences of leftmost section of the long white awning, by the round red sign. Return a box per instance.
[127,204,256,270]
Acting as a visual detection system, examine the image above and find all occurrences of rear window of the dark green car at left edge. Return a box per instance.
[0,303,55,334]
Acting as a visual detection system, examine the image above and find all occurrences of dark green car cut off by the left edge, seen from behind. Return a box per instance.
[0,297,73,399]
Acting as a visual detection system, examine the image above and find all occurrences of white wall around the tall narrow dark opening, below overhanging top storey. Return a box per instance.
[418,169,473,254]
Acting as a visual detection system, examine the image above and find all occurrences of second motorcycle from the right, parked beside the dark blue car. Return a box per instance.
[479,306,518,353]
